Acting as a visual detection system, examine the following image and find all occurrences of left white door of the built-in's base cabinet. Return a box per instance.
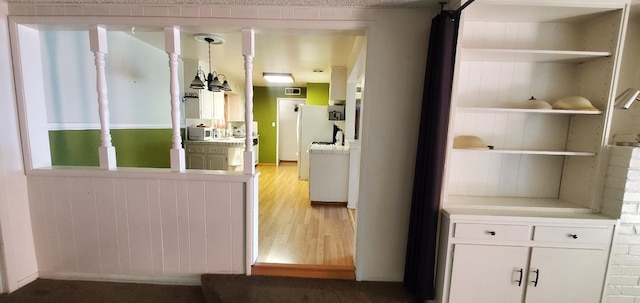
[449,245,529,303]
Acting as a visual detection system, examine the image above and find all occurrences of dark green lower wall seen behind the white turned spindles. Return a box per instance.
[49,129,176,168]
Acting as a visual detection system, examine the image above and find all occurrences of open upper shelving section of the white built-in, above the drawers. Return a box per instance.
[443,0,628,212]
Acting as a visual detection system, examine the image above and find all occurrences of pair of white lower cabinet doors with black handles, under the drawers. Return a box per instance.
[449,244,607,303]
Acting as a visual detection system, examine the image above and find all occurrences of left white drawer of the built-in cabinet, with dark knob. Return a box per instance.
[454,223,530,241]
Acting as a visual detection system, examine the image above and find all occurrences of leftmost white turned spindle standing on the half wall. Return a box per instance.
[89,26,117,170]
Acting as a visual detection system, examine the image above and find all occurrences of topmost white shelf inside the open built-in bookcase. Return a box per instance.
[462,48,611,63]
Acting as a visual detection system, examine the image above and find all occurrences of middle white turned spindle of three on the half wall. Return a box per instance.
[164,26,186,171]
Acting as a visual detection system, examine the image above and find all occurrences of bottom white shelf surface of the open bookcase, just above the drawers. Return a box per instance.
[446,195,591,214]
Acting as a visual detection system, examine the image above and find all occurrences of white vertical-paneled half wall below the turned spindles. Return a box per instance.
[28,173,245,284]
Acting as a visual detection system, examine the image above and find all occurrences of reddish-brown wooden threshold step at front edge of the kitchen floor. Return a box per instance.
[251,263,356,280]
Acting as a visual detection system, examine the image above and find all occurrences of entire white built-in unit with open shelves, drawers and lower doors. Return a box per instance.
[435,0,628,303]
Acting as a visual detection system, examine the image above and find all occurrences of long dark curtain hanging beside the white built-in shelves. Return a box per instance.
[404,11,459,302]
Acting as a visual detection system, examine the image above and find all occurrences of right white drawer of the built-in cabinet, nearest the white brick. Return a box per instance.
[533,226,613,244]
